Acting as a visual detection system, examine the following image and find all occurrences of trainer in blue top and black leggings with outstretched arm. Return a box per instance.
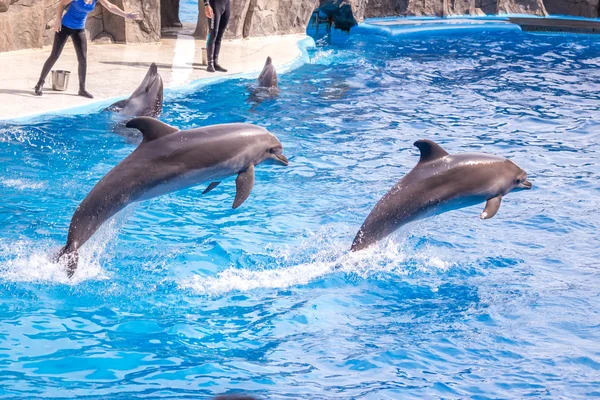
[34,0,140,99]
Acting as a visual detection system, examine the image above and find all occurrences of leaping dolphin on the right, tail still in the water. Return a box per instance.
[351,140,532,251]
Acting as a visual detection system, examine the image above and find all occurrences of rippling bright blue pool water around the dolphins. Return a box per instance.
[0,25,600,399]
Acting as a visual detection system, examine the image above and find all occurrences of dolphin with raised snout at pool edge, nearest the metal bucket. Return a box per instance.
[107,63,163,117]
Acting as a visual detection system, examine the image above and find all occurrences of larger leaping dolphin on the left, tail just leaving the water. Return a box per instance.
[57,117,288,277]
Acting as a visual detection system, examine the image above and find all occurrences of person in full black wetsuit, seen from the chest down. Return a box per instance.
[204,0,231,72]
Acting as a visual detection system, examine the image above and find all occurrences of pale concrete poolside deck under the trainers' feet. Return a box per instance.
[0,27,306,120]
